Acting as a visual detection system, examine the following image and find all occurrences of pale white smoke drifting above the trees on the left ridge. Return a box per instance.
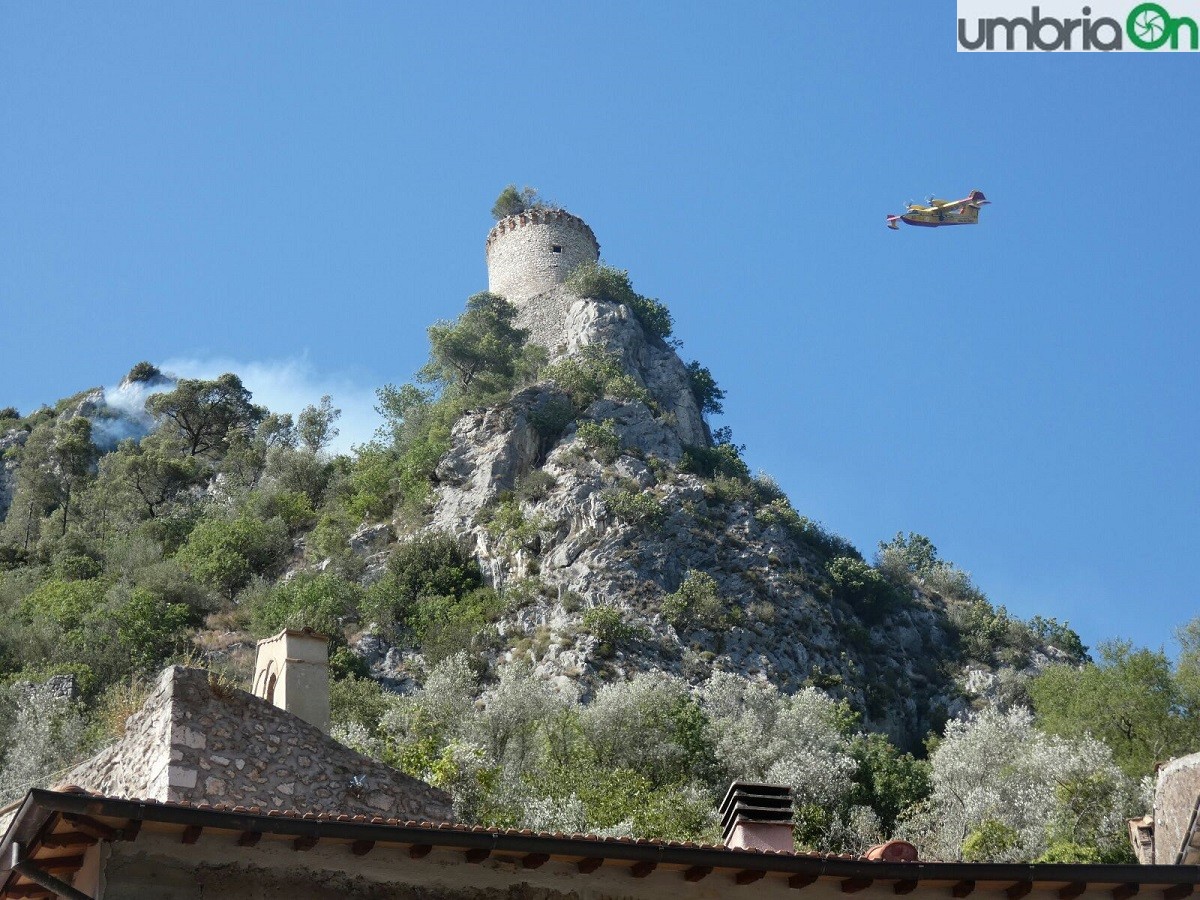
[158,358,383,454]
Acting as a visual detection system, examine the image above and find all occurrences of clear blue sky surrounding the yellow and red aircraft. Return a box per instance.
[0,0,1200,650]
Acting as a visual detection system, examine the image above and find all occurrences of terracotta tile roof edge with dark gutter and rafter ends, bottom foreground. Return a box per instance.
[7,788,1200,900]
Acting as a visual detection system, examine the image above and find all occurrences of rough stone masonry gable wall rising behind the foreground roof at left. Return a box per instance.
[67,666,451,822]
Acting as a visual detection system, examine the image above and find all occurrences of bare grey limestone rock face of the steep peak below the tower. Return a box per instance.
[420,287,955,743]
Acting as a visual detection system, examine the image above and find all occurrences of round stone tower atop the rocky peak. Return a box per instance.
[487,209,600,304]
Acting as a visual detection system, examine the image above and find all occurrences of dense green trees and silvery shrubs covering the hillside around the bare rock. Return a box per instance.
[0,232,1200,860]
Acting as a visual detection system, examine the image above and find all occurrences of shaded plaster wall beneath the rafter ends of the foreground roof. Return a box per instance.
[91,829,1142,900]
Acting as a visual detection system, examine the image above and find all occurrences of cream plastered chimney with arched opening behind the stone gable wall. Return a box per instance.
[254,628,329,732]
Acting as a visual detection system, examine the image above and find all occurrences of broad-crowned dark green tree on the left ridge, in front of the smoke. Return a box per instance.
[146,372,266,456]
